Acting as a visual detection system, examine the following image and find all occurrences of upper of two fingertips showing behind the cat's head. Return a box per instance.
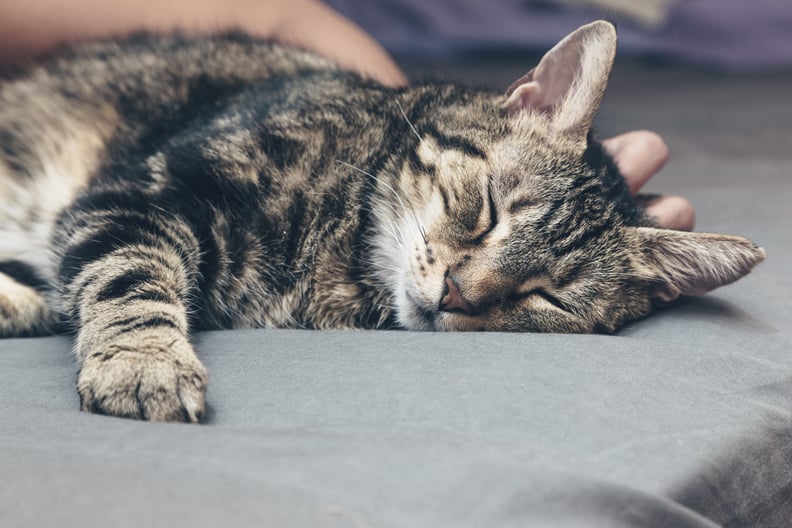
[603,130,668,195]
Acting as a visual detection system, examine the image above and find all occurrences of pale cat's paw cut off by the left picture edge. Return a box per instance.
[0,271,58,337]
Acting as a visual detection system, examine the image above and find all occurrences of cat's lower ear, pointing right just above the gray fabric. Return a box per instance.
[634,227,765,301]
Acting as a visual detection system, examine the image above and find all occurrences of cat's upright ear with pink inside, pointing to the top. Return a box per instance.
[506,20,616,140]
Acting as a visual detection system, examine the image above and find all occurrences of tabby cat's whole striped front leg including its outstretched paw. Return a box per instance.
[58,211,207,422]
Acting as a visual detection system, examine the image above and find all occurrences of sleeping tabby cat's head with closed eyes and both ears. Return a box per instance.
[375,22,764,332]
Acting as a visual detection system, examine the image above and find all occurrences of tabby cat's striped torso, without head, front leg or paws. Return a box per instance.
[0,35,396,328]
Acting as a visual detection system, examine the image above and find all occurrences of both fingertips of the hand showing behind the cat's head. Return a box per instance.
[603,130,696,231]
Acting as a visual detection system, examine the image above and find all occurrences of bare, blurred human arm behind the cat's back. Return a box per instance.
[0,0,406,86]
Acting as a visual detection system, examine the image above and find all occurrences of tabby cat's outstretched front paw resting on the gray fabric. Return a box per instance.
[77,335,208,422]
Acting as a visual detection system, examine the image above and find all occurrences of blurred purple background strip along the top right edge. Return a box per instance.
[327,0,792,71]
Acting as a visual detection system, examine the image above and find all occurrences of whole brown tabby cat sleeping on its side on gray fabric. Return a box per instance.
[0,22,764,421]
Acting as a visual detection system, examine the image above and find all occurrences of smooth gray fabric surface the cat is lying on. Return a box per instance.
[0,62,792,528]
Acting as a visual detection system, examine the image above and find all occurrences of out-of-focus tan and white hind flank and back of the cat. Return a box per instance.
[0,33,342,278]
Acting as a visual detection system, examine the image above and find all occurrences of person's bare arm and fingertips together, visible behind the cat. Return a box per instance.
[0,0,695,230]
